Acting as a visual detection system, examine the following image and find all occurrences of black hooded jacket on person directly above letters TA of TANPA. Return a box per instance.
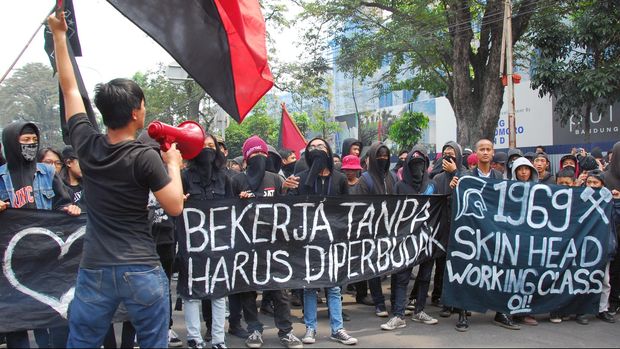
[353,142,396,195]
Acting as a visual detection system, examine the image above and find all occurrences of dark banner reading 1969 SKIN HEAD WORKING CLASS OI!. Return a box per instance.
[442,177,612,314]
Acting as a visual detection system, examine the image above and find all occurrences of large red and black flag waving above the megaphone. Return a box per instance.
[108,0,273,122]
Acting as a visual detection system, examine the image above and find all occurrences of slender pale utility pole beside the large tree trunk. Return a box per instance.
[499,0,517,148]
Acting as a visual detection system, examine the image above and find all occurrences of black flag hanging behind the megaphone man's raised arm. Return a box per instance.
[44,0,99,145]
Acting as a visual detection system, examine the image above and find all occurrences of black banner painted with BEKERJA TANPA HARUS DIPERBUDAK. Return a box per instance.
[177,195,448,298]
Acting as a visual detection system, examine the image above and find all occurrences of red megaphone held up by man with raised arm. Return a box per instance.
[148,121,205,160]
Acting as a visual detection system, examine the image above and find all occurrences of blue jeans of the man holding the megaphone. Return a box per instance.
[67,265,170,348]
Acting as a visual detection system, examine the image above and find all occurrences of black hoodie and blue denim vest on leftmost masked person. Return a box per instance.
[0,121,72,210]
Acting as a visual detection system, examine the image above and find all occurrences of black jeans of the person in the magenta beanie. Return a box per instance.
[239,290,293,338]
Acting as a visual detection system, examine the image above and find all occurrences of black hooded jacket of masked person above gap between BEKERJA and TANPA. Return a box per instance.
[289,137,349,195]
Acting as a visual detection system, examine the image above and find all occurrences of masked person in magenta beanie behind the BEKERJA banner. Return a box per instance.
[232,135,303,348]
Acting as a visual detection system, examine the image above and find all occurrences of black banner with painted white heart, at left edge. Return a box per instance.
[0,209,86,332]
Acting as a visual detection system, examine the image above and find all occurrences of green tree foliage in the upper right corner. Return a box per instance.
[528,0,620,137]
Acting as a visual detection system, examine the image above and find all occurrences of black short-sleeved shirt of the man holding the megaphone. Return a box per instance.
[67,114,170,268]
